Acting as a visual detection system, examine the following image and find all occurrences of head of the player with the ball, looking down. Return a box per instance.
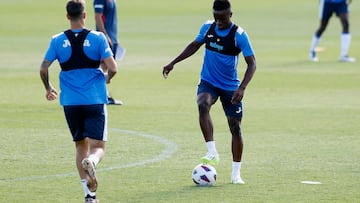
[213,0,232,29]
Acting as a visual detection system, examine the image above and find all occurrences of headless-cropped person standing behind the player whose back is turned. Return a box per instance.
[94,0,123,105]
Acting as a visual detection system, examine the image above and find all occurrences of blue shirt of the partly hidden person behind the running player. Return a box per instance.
[94,0,118,44]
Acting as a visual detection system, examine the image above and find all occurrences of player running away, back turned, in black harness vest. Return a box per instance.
[40,0,117,203]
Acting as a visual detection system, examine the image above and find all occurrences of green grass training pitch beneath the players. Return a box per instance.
[0,0,360,203]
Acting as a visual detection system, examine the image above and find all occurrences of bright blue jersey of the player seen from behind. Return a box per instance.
[45,29,113,106]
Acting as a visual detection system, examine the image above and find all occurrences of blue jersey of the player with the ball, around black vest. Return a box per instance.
[195,20,254,91]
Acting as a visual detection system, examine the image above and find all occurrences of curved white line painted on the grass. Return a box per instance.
[0,128,177,183]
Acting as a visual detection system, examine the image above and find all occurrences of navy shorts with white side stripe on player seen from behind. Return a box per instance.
[64,104,107,141]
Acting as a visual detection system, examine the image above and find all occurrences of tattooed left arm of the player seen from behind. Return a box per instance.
[40,59,58,101]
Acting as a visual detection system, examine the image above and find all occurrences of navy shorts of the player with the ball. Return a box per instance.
[197,80,243,118]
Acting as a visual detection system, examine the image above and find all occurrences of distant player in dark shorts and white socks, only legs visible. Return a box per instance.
[309,0,356,62]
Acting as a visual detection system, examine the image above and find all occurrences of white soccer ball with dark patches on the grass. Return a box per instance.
[192,164,216,186]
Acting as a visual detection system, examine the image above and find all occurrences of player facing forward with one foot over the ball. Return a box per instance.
[163,0,256,184]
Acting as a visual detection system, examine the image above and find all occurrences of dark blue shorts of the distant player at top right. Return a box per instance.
[319,1,349,21]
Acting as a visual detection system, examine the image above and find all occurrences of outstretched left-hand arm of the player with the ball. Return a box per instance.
[163,40,203,78]
